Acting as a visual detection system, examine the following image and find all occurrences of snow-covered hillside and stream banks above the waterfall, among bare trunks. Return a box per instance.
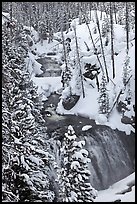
[29,9,135,135]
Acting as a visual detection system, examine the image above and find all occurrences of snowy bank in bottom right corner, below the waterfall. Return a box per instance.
[95,173,135,202]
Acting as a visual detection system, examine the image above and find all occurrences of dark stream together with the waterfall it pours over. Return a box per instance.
[35,57,135,190]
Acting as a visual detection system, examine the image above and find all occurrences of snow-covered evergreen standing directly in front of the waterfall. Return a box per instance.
[59,125,97,202]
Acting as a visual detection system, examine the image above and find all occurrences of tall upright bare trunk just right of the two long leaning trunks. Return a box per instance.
[110,2,115,79]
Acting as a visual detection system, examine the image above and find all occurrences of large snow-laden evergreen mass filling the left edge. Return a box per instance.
[2,21,55,202]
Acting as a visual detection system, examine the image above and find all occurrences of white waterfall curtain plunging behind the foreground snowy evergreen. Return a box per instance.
[46,122,135,190]
